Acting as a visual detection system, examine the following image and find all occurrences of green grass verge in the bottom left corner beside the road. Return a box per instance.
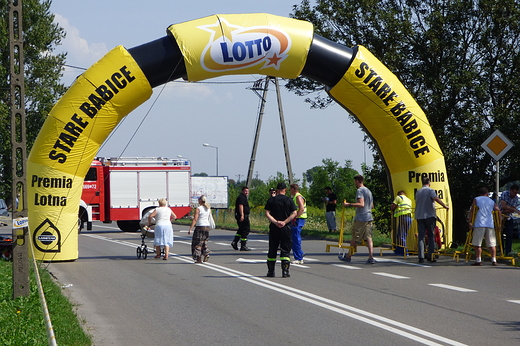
[0,260,92,346]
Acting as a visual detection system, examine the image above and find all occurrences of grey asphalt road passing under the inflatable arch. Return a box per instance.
[13,223,520,346]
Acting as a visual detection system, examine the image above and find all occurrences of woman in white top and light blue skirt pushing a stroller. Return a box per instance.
[148,198,177,260]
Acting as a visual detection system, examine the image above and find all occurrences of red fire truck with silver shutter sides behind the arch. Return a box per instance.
[78,157,191,231]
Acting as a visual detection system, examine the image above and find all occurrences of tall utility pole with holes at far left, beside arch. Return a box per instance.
[9,0,30,299]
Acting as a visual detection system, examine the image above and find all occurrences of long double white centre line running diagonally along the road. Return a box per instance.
[85,235,466,346]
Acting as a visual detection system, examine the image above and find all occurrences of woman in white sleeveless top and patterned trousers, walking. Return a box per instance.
[188,196,211,263]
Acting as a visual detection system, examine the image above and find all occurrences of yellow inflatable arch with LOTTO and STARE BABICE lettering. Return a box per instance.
[27,13,451,261]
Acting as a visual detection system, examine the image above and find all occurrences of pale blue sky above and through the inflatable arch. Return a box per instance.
[51,0,372,180]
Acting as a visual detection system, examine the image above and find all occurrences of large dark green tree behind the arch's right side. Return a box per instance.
[288,0,520,240]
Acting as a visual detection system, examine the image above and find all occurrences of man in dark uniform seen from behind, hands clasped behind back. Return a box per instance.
[265,183,296,278]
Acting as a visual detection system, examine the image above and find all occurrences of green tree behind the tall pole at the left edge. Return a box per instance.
[0,0,66,196]
